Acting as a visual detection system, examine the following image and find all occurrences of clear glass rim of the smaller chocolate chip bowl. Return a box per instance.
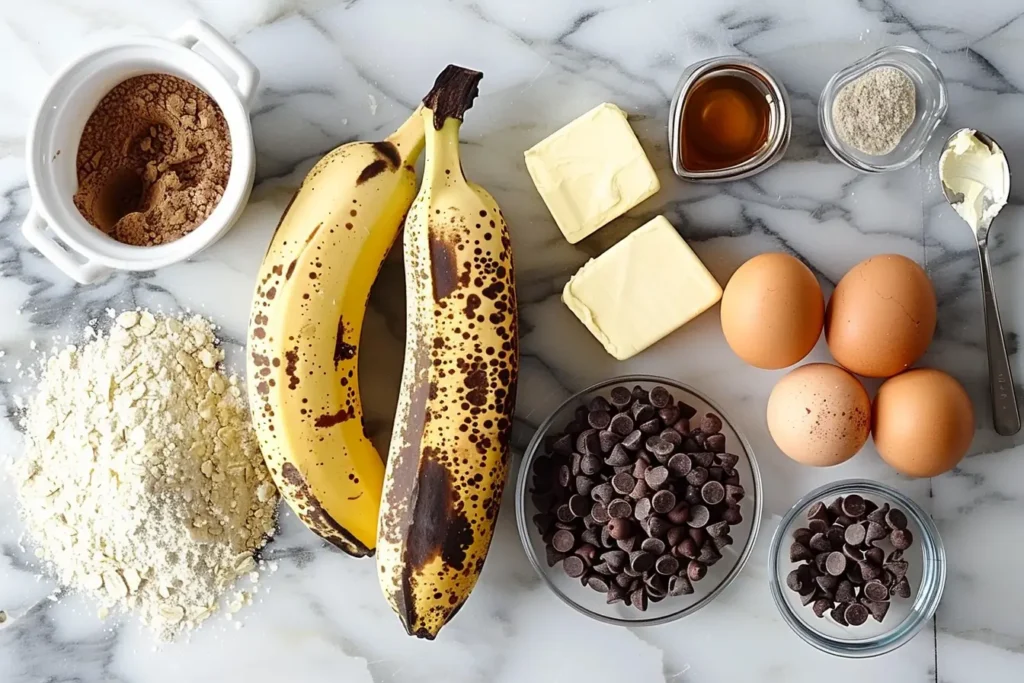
[768,479,946,658]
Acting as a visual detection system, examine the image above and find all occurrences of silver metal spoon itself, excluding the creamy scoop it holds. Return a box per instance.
[939,129,1021,436]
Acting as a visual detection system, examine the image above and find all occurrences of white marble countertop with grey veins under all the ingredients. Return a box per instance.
[0,0,1024,683]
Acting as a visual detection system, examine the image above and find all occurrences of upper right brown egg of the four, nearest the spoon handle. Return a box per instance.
[825,254,936,377]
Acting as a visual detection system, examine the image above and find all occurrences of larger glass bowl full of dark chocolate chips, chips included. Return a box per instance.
[516,376,761,626]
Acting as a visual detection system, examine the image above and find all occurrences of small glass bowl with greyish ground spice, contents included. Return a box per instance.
[818,46,948,173]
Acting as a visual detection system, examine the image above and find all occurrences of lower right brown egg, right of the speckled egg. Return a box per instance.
[871,368,974,477]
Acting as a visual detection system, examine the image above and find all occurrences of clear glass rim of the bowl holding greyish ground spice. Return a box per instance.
[817,45,949,173]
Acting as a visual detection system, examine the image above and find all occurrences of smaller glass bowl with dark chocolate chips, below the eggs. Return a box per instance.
[768,479,946,657]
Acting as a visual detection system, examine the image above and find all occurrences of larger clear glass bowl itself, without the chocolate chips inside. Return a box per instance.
[516,375,762,627]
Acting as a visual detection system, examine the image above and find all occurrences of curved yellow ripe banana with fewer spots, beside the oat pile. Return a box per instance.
[247,111,423,557]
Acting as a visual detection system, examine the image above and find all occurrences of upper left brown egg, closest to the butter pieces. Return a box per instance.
[722,254,824,370]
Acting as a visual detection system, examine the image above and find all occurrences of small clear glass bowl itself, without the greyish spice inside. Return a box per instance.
[818,45,947,173]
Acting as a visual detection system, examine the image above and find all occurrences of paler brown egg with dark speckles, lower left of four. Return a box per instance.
[768,362,871,467]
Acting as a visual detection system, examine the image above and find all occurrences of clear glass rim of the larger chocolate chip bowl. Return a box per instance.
[515,374,764,627]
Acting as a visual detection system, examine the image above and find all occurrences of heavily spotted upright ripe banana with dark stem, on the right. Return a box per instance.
[377,67,519,639]
